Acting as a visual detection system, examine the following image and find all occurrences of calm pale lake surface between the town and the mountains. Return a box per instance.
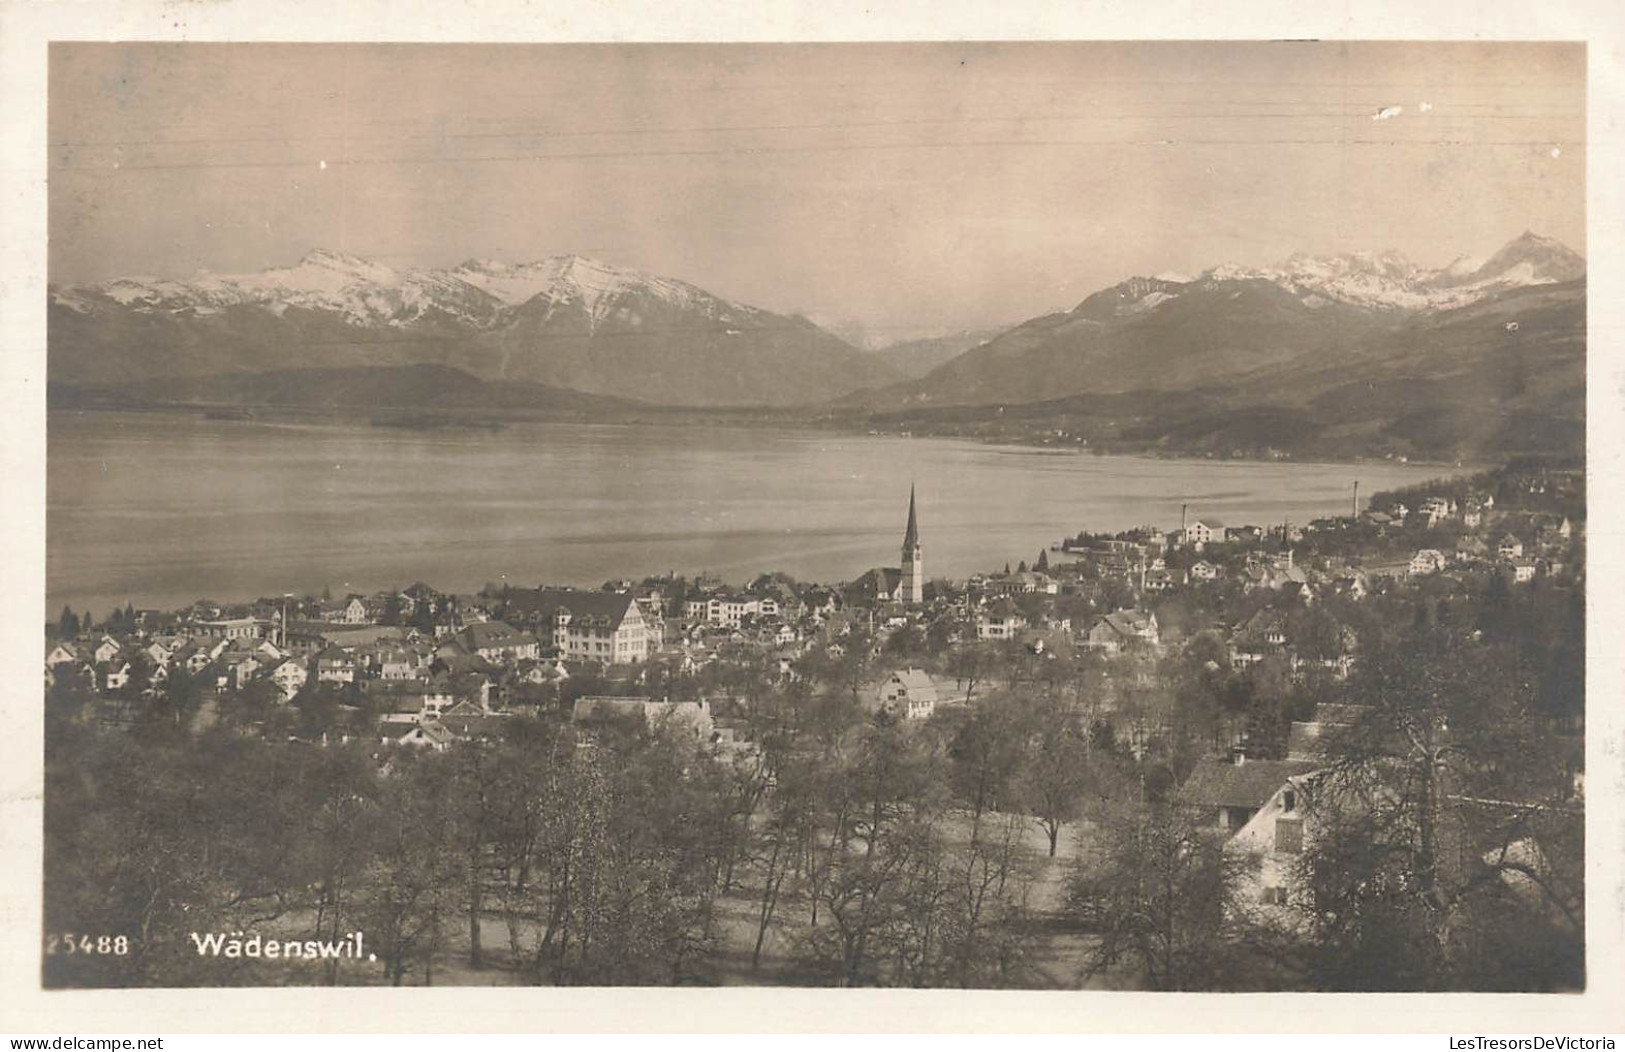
[46,411,1445,616]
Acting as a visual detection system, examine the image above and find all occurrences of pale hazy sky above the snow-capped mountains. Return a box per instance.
[50,42,1586,338]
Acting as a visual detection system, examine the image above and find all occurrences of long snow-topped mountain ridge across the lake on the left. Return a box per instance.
[49,250,902,406]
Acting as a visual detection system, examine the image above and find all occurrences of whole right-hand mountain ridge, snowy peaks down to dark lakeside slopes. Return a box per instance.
[842,233,1586,459]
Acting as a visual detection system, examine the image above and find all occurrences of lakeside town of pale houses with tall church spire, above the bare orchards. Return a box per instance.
[44,472,1583,753]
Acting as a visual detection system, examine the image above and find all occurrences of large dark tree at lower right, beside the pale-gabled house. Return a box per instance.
[1298,628,1584,989]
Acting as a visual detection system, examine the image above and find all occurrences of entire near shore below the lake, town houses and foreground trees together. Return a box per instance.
[44,462,1584,989]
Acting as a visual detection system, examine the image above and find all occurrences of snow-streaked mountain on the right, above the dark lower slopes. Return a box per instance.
[852,234,1586,410]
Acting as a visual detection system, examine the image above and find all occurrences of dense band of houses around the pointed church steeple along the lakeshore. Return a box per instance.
[46,478,1575,757]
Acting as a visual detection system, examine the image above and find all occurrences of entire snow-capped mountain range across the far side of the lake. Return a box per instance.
[49,233,1586,457]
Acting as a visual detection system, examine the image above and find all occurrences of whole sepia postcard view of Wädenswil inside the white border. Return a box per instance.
[9,18,1619,1021]
